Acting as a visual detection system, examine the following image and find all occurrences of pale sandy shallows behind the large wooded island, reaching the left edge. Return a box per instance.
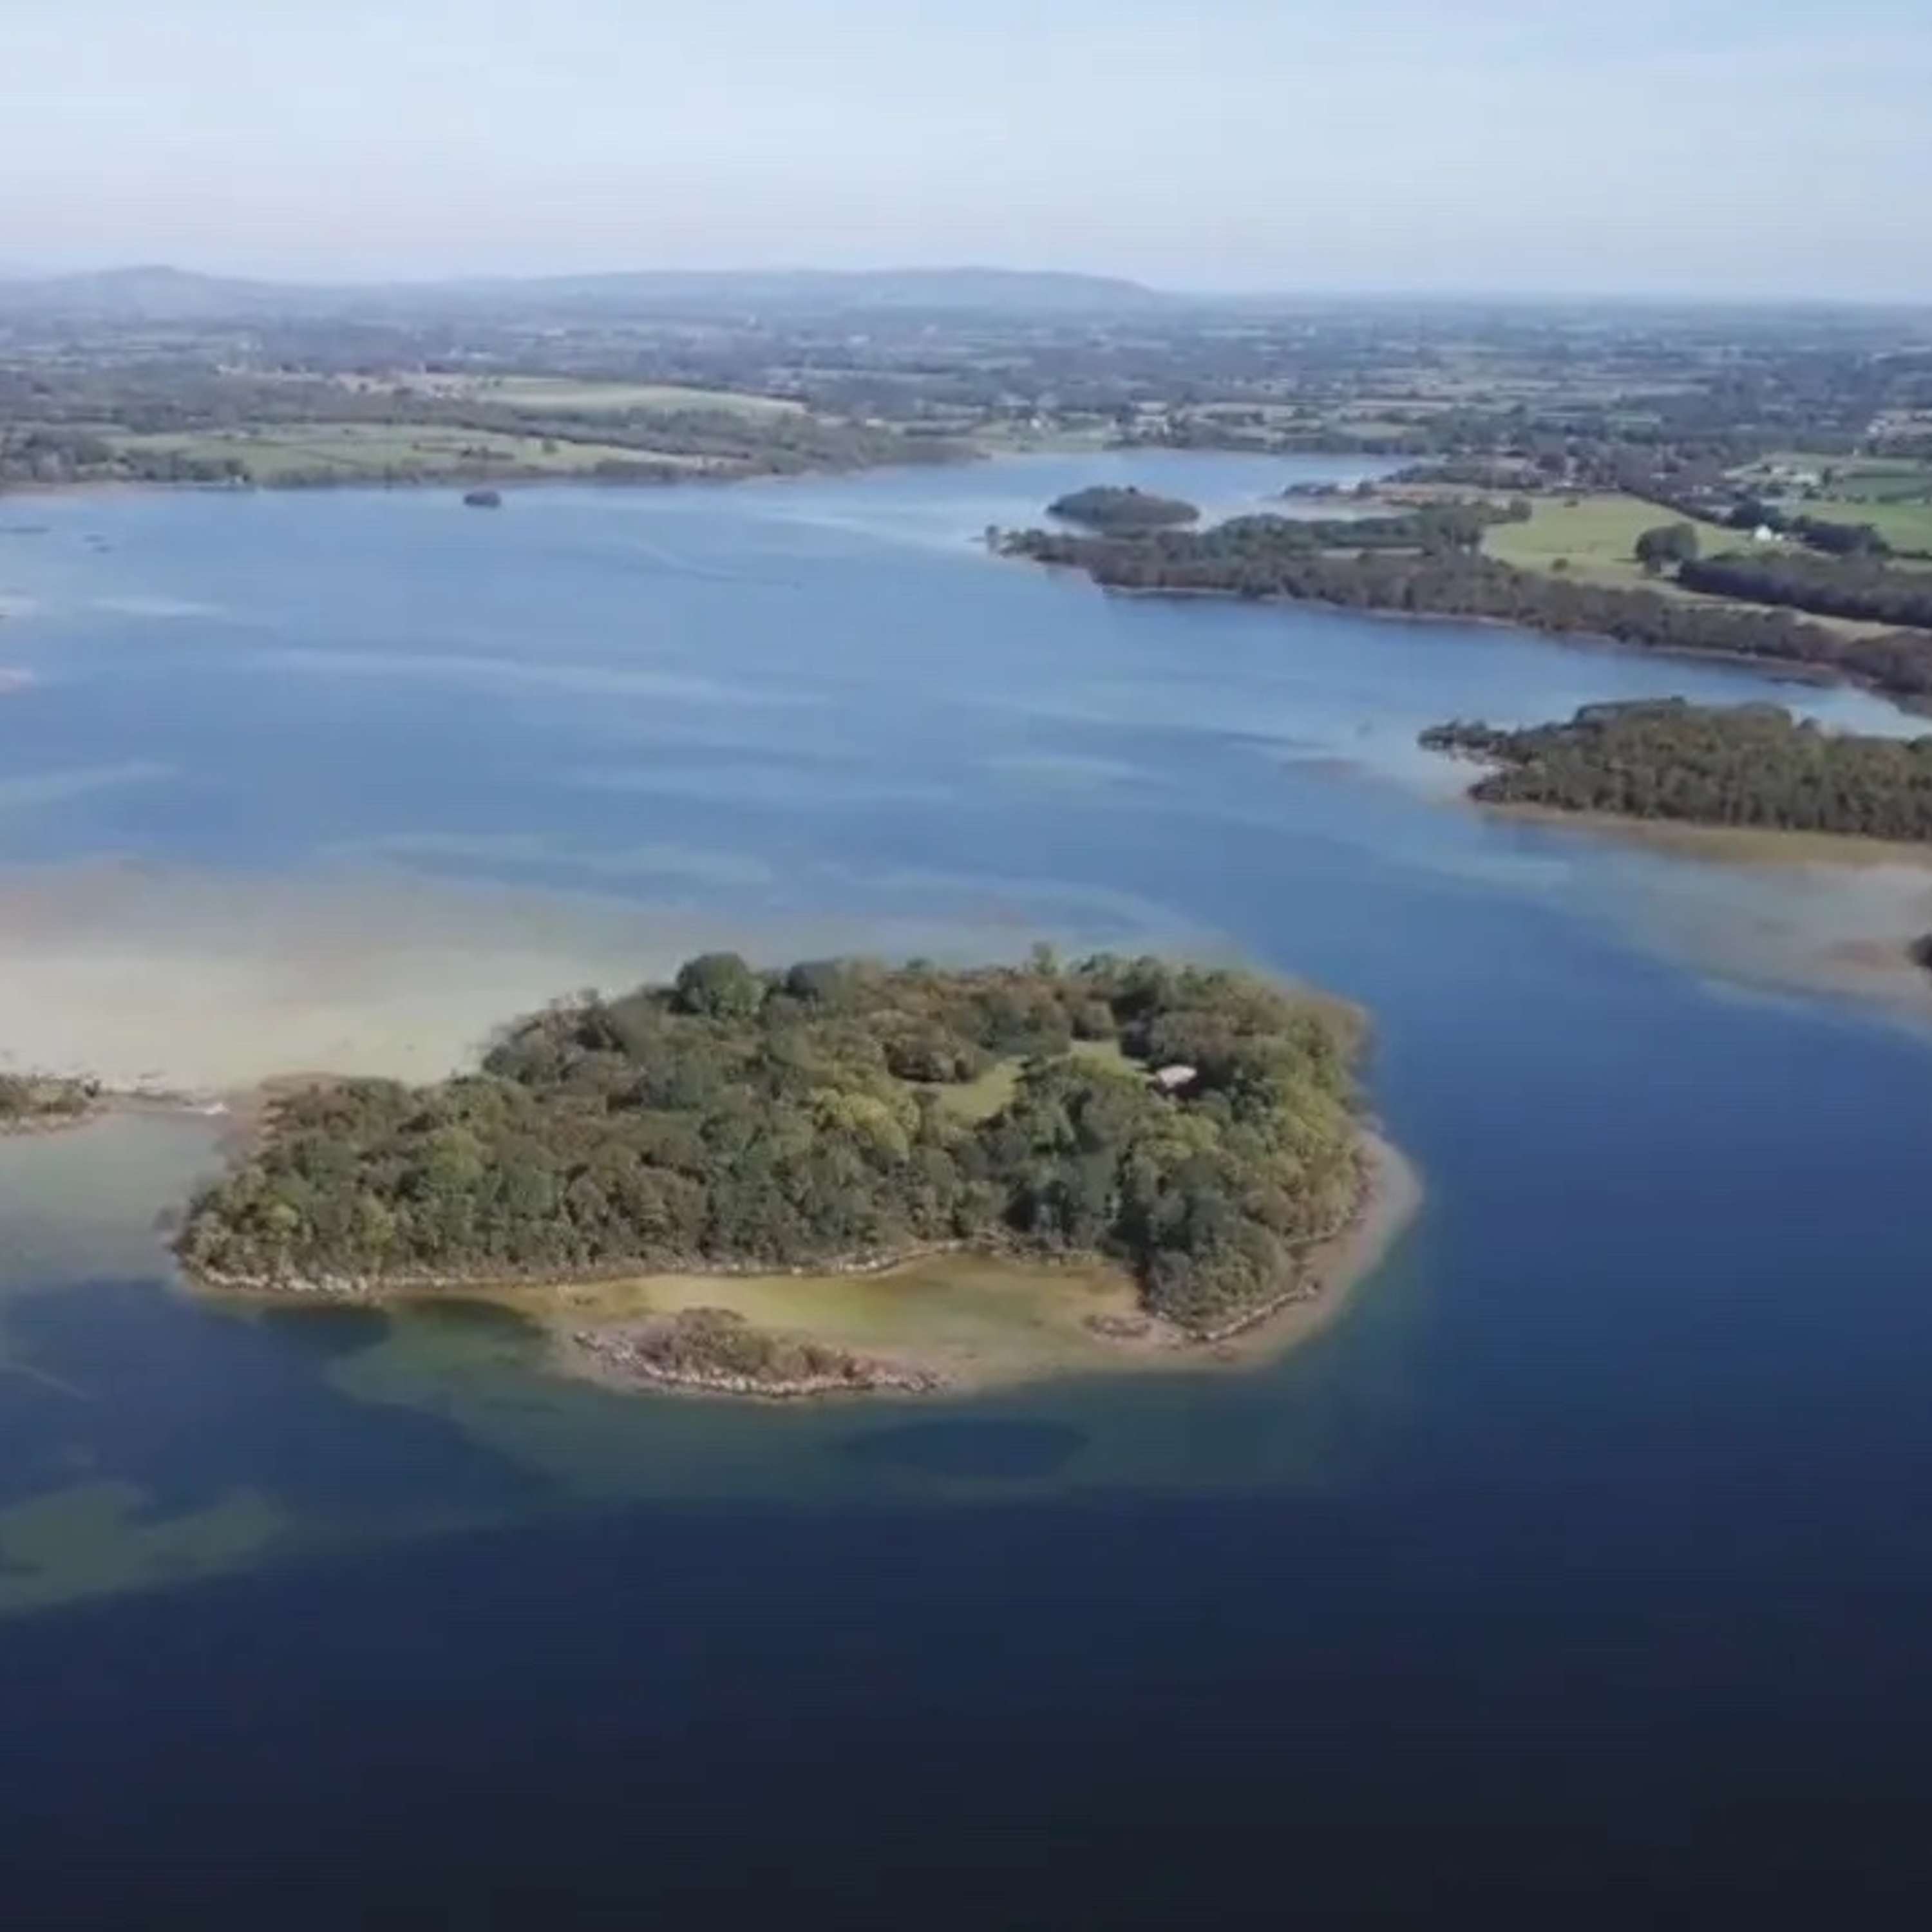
[0,860,1198,1095]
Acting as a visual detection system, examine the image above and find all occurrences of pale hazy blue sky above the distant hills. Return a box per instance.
[0,0,1932,298]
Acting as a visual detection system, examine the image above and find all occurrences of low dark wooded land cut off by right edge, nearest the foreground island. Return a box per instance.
[1422,697,1932,838]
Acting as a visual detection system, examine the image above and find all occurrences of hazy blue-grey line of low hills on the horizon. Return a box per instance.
[0,267,1173,323]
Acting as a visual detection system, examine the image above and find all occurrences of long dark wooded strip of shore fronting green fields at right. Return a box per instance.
[1005,506,1932,697]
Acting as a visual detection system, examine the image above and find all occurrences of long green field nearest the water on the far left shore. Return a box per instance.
[110,423,711,483]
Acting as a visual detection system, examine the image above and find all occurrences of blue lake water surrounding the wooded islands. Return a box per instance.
[0,454,1932,1926]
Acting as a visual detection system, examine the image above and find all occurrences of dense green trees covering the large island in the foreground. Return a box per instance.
[180,954,1362,1329]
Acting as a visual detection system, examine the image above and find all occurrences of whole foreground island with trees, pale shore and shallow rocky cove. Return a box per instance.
[178,949,1412,1395]
